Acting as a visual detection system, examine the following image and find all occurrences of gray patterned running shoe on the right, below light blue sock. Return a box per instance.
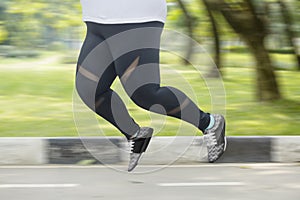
[204,114,227,163]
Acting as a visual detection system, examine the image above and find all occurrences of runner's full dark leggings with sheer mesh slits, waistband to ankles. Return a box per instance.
[76,22,210,138]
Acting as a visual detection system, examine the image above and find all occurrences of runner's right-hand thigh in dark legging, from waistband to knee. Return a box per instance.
[108,22,164,95]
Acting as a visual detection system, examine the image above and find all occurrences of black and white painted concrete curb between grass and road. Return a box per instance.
[0,136,300,165]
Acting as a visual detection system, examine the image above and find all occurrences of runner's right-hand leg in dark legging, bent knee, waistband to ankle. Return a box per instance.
[104,22,210,132]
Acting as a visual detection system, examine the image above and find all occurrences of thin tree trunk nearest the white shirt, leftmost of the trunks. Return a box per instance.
[177,0,194,65]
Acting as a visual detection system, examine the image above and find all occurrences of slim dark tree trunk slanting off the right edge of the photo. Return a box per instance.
[277,0,300,70]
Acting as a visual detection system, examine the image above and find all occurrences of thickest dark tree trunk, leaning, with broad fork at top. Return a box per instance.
[208,0,281,101]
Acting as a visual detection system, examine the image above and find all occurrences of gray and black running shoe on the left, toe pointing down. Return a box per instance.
[128,127,153,172]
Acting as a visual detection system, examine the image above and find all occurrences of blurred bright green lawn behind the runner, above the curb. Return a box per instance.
[0,53,300,137]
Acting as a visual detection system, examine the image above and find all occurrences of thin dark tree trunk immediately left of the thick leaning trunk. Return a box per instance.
[202,0,222,77]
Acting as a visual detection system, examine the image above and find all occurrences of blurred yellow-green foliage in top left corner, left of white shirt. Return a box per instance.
[1,0,82,48]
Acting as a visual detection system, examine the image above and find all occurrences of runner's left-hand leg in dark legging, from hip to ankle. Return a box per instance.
[76,23,139,138]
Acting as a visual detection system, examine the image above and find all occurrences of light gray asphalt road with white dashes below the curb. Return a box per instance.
[0,163,300,200]
